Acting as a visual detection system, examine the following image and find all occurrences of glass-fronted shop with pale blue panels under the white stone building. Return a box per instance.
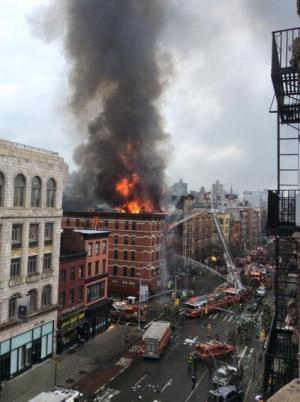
[0,321,54,380]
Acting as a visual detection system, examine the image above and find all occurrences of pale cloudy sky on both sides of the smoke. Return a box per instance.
[0,0,300,195]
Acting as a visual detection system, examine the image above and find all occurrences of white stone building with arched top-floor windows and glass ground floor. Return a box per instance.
[0,140,67,380]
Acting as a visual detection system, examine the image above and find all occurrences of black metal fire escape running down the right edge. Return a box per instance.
[264,28,300,397]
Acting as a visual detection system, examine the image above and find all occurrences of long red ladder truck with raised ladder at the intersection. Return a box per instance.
[184,288,244,318]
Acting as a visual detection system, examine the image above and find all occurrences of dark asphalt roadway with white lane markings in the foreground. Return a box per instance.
[94,312,255,402]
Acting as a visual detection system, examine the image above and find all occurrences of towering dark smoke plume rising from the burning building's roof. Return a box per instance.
[52,0,169,210]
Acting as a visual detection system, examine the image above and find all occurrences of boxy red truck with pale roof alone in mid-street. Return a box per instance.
[142,321,171,359]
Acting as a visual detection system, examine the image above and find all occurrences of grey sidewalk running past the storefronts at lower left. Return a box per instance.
[0,325,141,402]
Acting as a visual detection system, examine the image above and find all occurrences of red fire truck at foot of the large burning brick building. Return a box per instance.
[111,296,146,322]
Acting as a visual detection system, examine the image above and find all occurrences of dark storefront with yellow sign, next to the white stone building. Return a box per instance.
[57,309,88,353]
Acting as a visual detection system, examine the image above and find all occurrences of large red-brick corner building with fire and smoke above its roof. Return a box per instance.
[63,212,165,296]
